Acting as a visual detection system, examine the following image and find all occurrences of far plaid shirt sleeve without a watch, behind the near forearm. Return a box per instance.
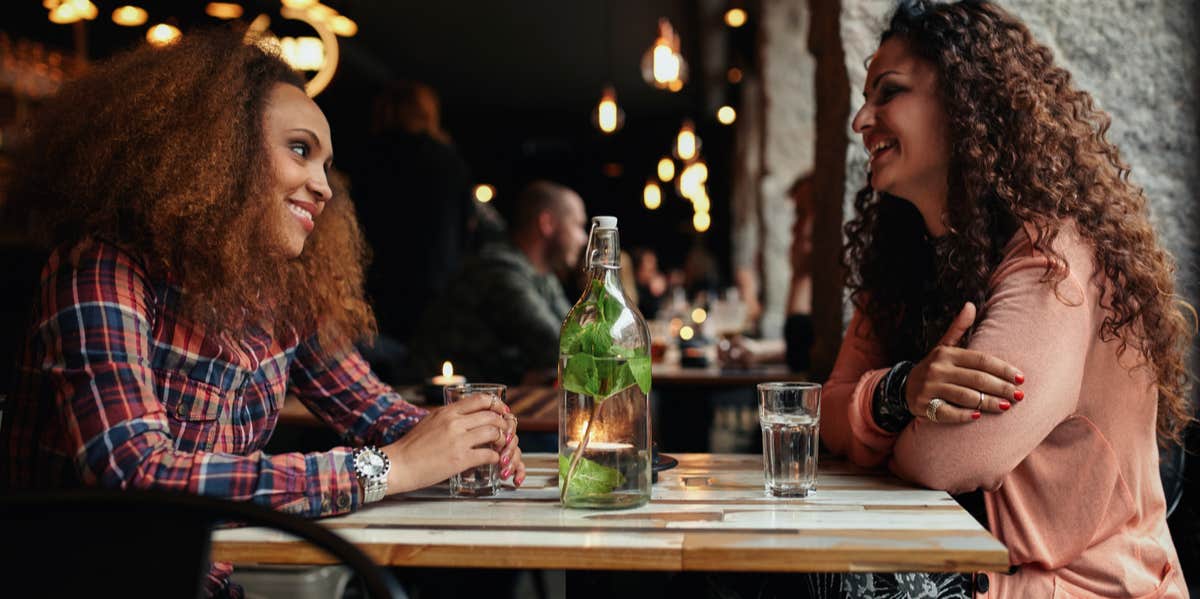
[289,337,428,447]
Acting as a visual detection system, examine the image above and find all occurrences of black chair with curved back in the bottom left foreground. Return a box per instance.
[0,489,404,598]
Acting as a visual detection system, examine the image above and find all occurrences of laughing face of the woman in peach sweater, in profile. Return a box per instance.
[853,37,950,235]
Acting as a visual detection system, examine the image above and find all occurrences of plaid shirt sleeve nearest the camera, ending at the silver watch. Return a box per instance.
[36,244,361,517]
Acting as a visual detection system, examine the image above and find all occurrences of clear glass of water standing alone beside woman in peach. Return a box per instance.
[758,383,821,497]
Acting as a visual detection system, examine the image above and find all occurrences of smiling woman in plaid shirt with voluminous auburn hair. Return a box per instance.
[0,29,526,595]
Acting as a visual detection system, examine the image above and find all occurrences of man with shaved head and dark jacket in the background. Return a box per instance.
[414,181,588,383]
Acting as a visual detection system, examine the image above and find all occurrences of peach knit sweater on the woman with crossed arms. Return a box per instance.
[821,226,1187,598]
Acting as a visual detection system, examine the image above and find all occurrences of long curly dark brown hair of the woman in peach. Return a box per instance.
[842,0,1194,444]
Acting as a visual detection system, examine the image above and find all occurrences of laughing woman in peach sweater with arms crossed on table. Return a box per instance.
[821,1,1194,598]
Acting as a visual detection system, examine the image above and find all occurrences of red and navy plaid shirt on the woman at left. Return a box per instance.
[0,240,426,595]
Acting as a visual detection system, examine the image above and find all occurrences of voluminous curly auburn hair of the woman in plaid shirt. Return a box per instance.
[10,28,374,346]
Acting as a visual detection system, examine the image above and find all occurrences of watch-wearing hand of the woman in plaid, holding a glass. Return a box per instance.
[383,395,510,495]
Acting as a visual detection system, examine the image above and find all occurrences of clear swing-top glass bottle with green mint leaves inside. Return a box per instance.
[558,216,650,509]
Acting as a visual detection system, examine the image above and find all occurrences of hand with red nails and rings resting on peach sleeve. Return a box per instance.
[905,301,1025,423]
